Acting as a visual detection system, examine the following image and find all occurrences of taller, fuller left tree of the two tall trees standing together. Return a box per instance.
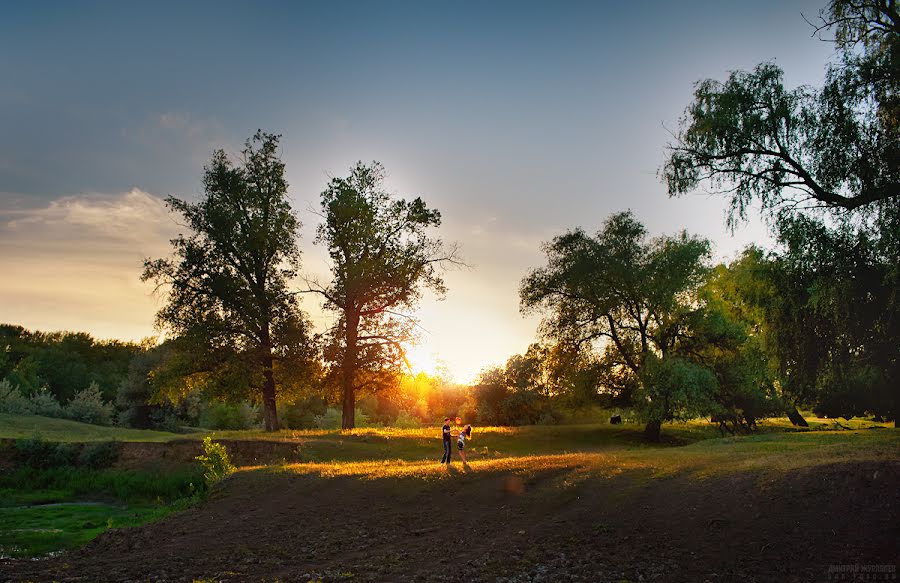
[142,131,311,431]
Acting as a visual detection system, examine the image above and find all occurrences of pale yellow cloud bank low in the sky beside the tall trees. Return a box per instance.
[0,189,179,339]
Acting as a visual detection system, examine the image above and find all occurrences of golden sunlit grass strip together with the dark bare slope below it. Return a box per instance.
[0,420,900,582]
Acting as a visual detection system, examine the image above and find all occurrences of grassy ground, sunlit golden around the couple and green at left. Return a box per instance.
[0,408,900,556]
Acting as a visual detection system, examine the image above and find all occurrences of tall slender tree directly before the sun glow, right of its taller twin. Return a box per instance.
[308,162,460,429]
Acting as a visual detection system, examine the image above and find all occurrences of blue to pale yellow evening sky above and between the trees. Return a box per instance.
[0,0,833,382]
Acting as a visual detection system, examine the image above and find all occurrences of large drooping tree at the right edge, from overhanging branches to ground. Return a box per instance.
[661,0,900,421]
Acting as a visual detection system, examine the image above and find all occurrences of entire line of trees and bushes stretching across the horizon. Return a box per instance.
[0,0,900,439]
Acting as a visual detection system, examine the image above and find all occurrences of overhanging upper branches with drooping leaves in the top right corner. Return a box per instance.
[661,0,900,227]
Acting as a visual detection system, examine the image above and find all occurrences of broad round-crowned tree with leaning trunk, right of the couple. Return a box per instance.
[520,212,709,440]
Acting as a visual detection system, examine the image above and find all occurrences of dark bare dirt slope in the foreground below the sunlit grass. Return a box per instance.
[0,462,900,582]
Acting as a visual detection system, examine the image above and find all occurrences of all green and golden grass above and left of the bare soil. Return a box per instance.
[0,415,900,580]
